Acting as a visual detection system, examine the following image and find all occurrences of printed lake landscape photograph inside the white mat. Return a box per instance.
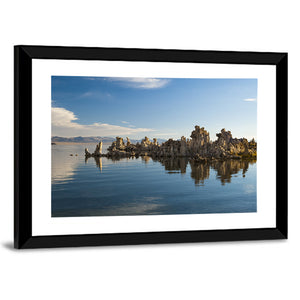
[51,76,257,218]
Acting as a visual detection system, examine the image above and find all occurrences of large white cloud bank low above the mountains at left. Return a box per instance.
[51,107,154,137]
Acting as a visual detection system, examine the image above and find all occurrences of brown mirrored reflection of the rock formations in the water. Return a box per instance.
[86,156,256,185]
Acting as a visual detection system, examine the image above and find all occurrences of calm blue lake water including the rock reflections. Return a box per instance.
[52,145,256,217]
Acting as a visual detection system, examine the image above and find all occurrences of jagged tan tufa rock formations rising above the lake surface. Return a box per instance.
[85,126,257,162]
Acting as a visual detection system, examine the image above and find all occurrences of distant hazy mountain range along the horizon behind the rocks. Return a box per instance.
[51,136,166,144]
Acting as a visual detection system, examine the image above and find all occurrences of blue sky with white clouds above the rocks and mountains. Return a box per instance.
[52,76,257,140]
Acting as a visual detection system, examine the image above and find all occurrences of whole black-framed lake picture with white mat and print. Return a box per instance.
[14,45,287,248]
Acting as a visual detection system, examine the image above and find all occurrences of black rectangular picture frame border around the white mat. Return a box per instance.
[14,45,288,249]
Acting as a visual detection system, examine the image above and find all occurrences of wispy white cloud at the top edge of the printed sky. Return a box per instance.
[107,77,170,89]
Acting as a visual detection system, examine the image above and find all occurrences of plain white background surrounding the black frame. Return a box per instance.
[0,0,300,300]
